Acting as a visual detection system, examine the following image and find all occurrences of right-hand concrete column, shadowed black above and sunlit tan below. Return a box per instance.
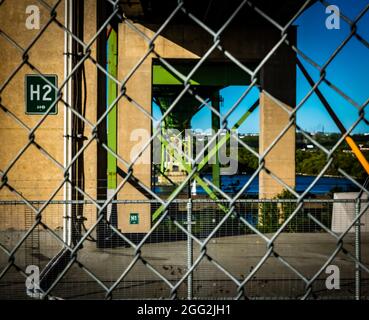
[259,32,296,199]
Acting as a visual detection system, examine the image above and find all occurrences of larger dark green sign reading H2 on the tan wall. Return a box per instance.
[25,74,58,114]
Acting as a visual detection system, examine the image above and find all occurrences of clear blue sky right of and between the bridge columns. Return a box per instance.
[153,0,369,133]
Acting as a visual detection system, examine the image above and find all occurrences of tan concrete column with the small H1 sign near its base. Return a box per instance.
[117,24,152,233]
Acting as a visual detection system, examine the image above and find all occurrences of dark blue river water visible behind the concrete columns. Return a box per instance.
[154,174,356,195]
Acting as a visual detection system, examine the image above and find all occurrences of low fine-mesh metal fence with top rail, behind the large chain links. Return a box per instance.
[0,199,369,299]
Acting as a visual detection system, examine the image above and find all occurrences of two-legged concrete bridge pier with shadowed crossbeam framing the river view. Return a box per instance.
[118,23,296,233]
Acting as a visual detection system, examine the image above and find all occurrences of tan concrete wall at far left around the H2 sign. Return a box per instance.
[0,0,96,229]
